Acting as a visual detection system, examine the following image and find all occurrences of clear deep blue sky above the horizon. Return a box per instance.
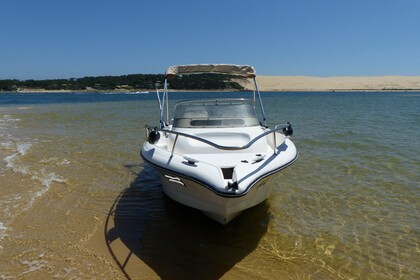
[0,0,420,79]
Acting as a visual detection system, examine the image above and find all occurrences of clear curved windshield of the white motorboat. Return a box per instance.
[173,99,259,128]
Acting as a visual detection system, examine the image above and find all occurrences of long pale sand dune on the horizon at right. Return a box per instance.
[240,76,420,91]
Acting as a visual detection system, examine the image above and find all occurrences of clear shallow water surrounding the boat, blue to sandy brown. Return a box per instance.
[0,93,420,279]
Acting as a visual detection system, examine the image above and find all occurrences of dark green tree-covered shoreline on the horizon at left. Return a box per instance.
[0,74,243,91]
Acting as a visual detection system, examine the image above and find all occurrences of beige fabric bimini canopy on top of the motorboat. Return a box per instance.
[166,64,256,78]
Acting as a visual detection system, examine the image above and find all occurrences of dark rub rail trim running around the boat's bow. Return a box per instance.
[140,151,299,198]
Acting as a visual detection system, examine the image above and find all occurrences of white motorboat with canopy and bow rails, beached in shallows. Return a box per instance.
[141,64,298,224]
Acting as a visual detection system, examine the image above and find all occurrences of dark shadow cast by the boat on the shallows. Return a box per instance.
[104,164,269,279]
